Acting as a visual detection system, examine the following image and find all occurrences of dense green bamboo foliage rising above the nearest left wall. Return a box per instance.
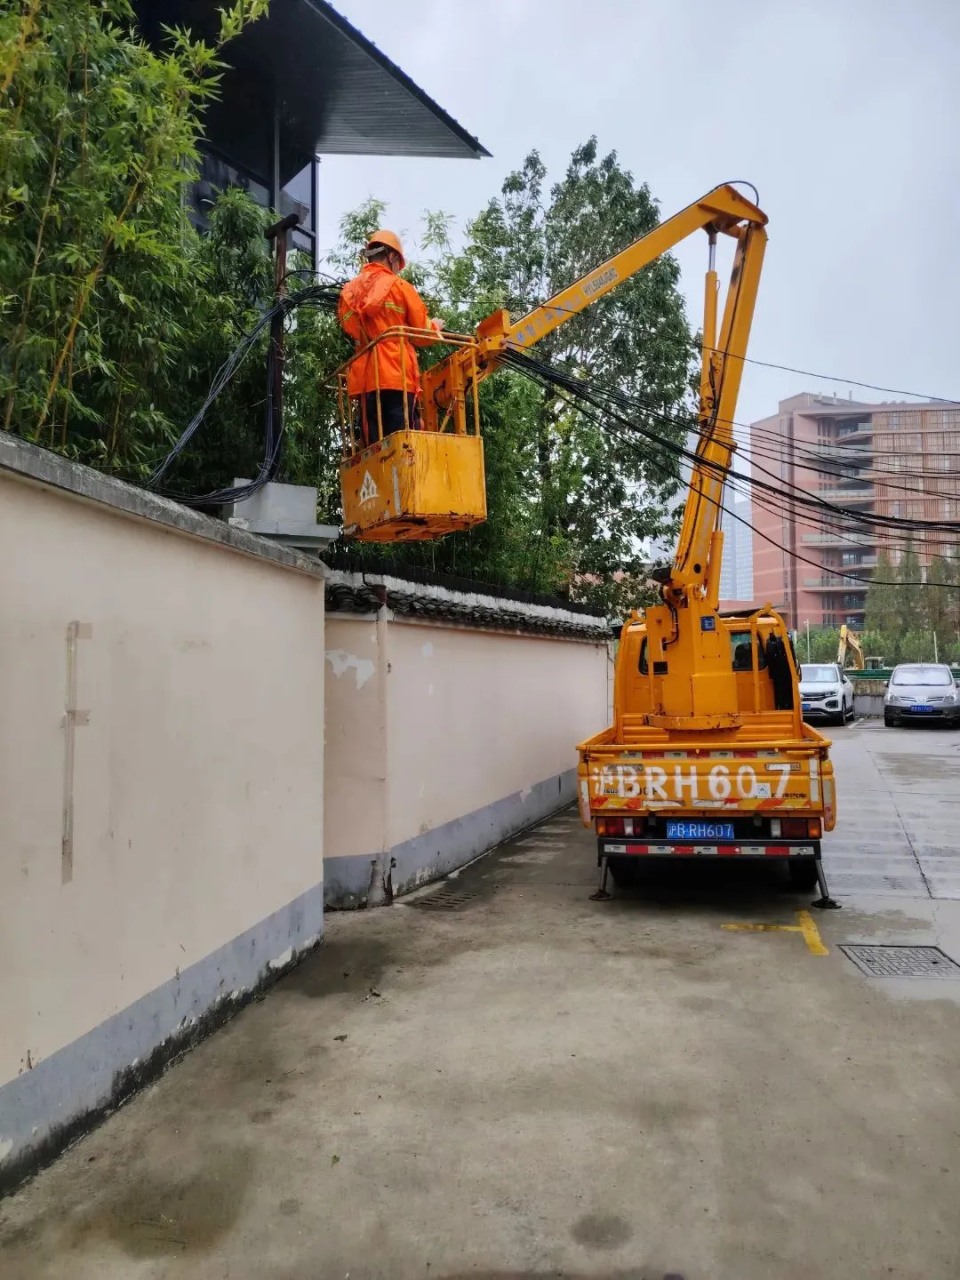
[0,0,268,476]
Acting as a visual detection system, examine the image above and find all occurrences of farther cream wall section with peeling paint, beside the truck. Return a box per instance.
[324,611,608,905]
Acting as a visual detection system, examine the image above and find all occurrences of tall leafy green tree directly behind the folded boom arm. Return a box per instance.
[438,138,694,591]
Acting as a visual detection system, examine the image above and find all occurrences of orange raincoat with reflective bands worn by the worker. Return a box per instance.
[337,262,435,396]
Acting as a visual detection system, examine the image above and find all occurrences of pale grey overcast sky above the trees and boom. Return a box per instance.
[320,0,960,421]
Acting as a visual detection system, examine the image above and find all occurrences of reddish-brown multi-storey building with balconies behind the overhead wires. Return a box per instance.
[750,392,960,628]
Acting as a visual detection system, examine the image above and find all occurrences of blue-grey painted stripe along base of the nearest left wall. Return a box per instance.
[0,884,324,1185]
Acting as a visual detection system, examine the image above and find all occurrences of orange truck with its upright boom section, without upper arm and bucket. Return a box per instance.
[577,187,836,905]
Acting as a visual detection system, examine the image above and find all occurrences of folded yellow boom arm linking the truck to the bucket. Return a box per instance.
[422,186,767,603]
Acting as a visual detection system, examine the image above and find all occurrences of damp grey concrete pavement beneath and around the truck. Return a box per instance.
[0,726,960,1280]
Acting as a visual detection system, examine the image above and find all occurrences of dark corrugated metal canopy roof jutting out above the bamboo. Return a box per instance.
[136,0,489,182]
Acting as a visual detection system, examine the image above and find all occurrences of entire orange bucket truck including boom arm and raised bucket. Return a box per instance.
[338,184,836,905]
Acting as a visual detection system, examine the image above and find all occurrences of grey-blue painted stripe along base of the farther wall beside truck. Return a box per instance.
[324,769,576,908]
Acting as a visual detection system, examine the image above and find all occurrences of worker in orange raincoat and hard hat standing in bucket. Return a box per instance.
[337,230,442,447]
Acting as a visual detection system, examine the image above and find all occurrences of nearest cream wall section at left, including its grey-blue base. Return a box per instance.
[0,455,324,1170]
